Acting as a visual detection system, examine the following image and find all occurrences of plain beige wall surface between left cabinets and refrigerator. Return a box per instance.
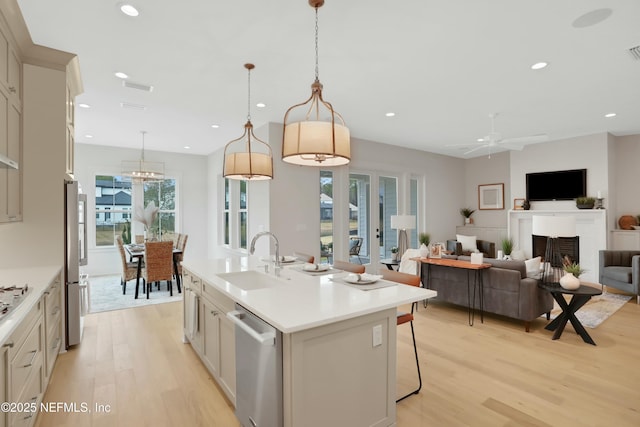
[0,64,66,268]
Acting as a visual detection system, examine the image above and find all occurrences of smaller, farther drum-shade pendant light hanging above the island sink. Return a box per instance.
[222,64,273,180]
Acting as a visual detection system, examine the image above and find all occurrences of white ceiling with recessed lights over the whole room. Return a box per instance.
[18,0,640,157]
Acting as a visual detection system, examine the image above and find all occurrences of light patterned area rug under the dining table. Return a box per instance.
[89,275,182,313]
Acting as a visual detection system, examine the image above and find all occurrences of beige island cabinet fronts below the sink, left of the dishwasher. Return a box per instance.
[183,269,236,405]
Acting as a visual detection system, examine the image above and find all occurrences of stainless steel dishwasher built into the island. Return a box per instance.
[227,304,283,427]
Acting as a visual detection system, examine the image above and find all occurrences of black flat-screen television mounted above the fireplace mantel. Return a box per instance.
[526,169,587,202]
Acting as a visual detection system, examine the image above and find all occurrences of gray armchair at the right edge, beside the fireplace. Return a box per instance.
[599,250,640,304]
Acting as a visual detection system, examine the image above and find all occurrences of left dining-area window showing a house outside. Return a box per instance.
[95,175,132,246]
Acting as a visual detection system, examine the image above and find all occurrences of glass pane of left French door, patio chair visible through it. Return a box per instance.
[349,174,371,264]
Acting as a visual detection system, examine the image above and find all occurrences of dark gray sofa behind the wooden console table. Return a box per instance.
[421,256,553,332]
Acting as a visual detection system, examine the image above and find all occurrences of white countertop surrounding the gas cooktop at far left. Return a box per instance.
[0,265,61,343]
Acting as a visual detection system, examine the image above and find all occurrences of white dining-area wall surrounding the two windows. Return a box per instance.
[75,144,208,275]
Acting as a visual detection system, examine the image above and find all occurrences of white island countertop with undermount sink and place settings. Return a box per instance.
[182,256,437,333]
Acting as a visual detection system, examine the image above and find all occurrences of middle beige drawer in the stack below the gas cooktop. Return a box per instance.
[10,321,44,398]
